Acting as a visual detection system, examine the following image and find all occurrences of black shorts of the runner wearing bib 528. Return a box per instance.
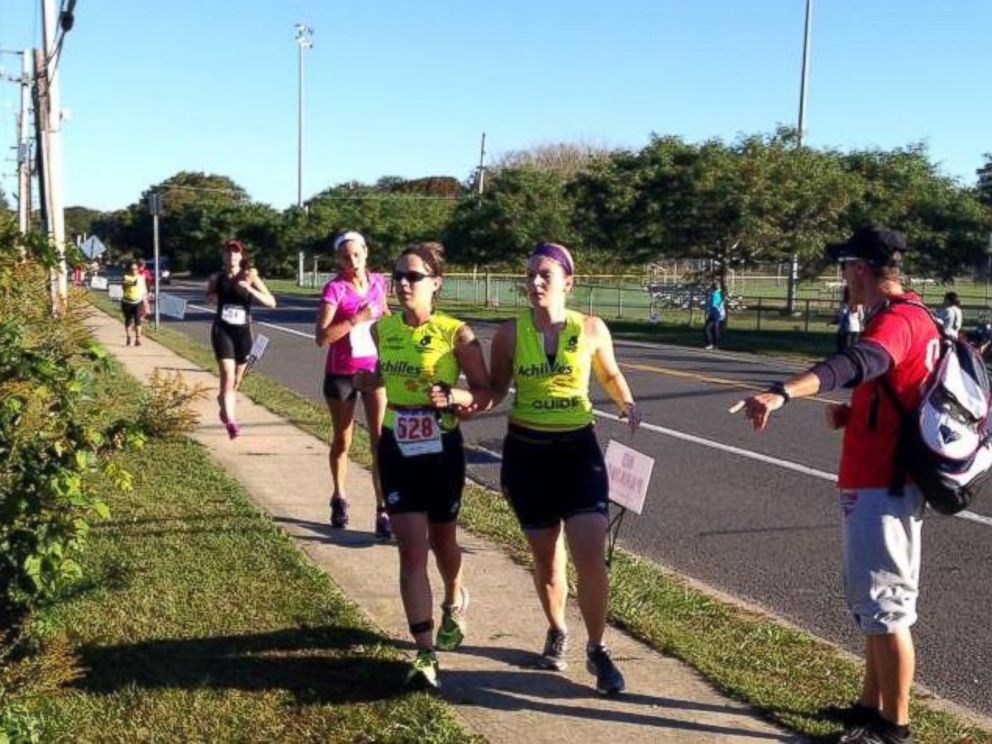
[379,427,465,524]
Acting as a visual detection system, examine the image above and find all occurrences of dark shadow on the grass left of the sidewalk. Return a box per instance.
[72,626,407,703]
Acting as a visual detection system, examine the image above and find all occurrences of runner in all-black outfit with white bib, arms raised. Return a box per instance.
[207,240,276,439]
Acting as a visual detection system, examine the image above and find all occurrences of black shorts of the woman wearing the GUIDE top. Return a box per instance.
[500,424,610,530]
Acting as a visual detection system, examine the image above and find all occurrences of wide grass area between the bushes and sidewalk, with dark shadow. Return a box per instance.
[20,350,478,742]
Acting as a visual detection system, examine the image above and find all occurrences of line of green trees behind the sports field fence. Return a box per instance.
[66,128,992,278]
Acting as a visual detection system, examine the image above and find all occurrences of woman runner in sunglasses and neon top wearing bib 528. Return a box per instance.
[355,243,491,687]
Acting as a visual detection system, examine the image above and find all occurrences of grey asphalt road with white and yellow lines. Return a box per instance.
[153,284,992,715]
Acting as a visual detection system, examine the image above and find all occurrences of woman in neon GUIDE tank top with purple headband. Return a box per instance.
[490,243,640,695]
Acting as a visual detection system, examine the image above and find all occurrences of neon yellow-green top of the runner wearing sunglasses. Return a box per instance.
[375,312,464,431]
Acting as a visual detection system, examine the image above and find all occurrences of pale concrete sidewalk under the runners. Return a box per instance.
[89,306,800,744]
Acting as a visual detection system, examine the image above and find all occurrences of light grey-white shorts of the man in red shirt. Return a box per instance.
[840,484,924,635]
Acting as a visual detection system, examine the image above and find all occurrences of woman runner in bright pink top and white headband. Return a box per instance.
[314,230,392,540]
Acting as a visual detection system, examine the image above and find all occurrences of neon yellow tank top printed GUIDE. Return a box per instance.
[510,310,592,430]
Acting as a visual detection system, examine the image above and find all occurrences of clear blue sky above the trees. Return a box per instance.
[0,0,992,210]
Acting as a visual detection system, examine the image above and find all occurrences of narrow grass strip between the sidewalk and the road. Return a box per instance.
[91,294,992,744]
